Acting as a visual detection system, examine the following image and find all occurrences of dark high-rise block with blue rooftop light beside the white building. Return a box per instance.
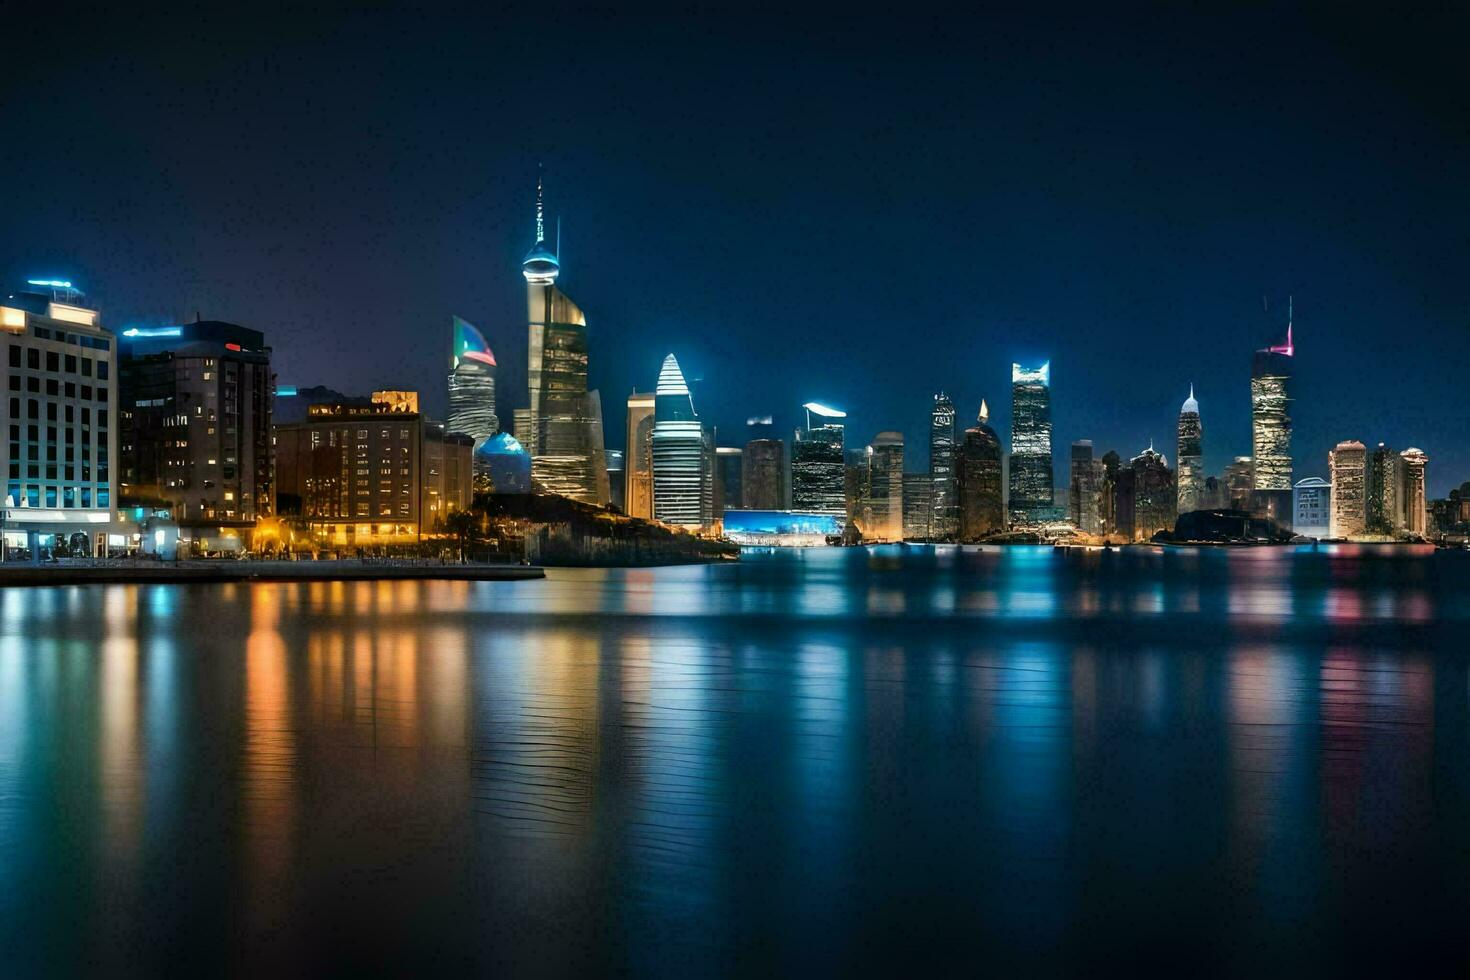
[118,320,275,539]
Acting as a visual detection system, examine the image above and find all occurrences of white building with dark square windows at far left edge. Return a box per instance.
[0,281,115,560]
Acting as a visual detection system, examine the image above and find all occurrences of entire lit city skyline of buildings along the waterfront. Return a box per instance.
[0,189,1470,557]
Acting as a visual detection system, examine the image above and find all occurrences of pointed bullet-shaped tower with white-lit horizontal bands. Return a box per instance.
[653,354,713,527]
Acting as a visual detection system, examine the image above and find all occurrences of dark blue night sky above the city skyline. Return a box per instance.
[0,6,1470,497]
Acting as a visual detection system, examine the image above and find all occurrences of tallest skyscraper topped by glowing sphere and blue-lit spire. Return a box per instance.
[516,170,609,507]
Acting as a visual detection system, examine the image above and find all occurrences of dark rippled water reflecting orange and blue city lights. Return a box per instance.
[0,547,1470,977]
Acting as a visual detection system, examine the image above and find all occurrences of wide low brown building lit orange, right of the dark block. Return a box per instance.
[275,392,475,547]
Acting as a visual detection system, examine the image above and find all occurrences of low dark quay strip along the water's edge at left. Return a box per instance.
[0,560,545,586]
